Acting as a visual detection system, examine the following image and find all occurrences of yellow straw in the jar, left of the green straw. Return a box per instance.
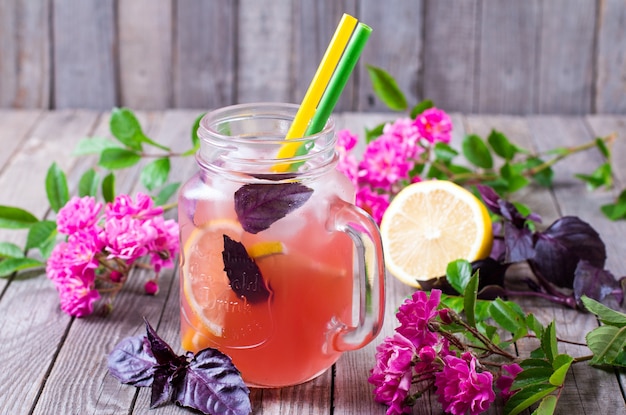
[274,13,357,171]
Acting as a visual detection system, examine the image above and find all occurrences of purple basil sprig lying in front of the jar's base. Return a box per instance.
[108,320,251,415]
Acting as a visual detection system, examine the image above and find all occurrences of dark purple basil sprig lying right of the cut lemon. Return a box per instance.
[472,185,626,309]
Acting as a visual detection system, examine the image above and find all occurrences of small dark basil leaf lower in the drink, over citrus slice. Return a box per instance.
[222,235,270,303]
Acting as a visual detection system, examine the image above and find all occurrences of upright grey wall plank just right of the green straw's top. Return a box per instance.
[350,0,425,111]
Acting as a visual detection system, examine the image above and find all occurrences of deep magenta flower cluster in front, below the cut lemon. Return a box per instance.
[369,290,521,415]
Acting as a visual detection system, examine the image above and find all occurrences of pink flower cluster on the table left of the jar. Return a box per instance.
[46,193,178,317]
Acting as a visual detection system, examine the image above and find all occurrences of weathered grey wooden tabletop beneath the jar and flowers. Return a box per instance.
[0,110,626,415]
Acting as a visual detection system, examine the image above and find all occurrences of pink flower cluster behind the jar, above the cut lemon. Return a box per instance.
[337,108,452,223]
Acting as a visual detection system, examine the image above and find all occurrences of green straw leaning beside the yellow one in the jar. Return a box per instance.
[304,23,372,137]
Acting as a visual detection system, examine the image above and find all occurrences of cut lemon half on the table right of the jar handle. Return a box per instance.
[380,180,493,288]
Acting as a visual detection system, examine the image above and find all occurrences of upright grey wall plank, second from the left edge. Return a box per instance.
[52,0,119,110]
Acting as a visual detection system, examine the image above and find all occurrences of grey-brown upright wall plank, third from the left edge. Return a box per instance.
[117,0,173,110]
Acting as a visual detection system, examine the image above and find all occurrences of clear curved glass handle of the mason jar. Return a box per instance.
[330,199,385,352]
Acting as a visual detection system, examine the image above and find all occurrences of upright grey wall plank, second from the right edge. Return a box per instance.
[536,0,597,114]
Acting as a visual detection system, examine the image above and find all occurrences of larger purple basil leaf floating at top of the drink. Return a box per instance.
[235,183,313,233]
